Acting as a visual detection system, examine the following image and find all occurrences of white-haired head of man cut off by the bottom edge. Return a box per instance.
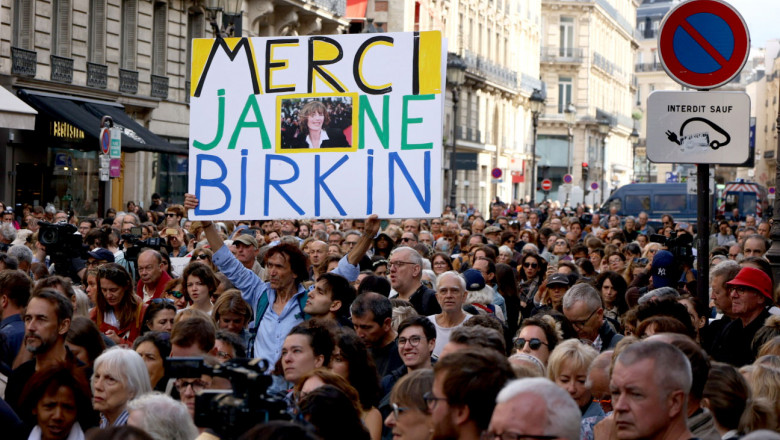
[480,377,580,440]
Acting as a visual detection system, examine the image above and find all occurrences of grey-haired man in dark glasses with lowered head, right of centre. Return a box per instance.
[563,284,623,352]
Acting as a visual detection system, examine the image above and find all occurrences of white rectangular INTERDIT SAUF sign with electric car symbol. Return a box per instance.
[647,91,750,165]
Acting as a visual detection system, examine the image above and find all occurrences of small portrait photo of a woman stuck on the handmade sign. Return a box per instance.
[282,101,351,149]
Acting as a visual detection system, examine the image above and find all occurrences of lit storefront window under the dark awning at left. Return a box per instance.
[47,148,100,216]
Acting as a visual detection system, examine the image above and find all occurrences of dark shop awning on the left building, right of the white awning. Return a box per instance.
[19,89,187,155]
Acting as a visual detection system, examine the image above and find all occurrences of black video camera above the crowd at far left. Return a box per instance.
[38,222,87,279]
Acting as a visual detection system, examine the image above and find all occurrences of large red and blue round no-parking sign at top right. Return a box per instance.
[658,0,750,90]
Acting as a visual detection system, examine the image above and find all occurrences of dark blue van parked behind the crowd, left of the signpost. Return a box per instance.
[598,183,697,226]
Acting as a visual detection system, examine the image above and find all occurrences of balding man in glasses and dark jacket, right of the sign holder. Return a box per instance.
[388,248,441,316]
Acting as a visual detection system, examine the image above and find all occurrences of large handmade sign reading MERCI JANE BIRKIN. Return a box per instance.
[189,31,446,219]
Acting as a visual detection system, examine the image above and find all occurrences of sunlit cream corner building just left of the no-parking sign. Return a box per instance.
[537,0,638,206]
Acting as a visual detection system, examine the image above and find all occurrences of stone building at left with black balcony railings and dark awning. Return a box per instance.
[0,0,349,215]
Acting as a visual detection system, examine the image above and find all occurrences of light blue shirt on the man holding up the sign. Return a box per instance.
[214,246,360,368]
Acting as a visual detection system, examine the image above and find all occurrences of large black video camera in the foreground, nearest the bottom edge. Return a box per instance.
[165,357,292,438]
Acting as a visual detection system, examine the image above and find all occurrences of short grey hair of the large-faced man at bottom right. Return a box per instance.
[615,341,693,400]
